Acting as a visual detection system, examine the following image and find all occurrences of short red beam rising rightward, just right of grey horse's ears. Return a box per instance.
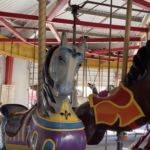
[88,45,139,54]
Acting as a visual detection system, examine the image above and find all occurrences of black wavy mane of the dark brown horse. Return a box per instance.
[124,40,150,87]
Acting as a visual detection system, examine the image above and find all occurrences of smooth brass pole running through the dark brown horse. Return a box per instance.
[117,0,132,150]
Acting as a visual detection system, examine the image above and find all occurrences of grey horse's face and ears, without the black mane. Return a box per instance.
[49,32,85,96]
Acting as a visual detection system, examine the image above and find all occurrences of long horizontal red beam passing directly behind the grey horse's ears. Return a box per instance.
[0,37,140,43]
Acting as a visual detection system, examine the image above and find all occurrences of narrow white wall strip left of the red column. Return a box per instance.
[0,55,6,99]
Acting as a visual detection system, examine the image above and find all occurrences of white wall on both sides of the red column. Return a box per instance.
[0,56,29,106]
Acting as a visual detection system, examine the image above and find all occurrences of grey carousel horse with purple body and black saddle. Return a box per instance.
[1,32,86,150]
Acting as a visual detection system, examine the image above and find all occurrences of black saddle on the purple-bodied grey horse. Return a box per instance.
[0,104,30,137]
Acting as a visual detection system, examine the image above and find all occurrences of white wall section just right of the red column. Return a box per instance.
[12,58,29,106]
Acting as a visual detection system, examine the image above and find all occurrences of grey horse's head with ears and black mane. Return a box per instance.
[40,32,86,116]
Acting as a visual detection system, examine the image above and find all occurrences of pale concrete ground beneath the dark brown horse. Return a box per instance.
[86,135,147,150]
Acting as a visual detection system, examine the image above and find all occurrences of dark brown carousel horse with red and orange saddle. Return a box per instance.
[76,41,150,145]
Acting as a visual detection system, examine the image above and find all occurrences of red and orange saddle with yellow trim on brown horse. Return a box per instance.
[89,82,145,127]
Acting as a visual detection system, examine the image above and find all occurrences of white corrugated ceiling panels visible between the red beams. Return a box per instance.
[0,0,149,61]
